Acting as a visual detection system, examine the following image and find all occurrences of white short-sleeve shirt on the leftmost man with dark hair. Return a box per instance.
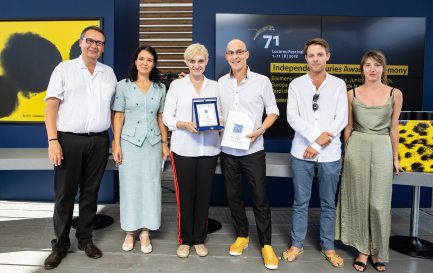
[45,55,117,133]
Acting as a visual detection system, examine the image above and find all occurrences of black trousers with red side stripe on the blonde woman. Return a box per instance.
[171,152,218,245]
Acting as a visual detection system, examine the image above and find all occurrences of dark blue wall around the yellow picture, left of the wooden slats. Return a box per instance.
[0,0,139,202]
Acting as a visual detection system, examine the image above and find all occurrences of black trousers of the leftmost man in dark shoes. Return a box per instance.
[52,131,109,251]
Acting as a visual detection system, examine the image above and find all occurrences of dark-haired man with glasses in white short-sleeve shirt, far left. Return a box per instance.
[45,26,117,269]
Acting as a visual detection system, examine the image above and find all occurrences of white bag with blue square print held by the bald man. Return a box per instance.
[221,111,255,150]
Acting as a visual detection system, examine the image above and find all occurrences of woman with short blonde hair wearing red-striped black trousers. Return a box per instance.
[163,44,221,258]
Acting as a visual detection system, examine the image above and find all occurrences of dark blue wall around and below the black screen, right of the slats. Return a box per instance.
[193,0,433,207]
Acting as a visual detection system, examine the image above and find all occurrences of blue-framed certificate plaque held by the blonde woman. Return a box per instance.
[192,98,224,131]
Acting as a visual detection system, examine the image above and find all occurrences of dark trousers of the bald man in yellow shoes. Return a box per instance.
[221,150,272,247]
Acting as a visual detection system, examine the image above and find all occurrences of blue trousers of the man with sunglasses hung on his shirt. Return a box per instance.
[291,157,341,251]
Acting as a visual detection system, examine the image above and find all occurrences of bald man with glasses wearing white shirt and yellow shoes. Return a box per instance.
[218,39,280,269]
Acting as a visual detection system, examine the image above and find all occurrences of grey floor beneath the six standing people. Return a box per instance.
[0,176,433,273]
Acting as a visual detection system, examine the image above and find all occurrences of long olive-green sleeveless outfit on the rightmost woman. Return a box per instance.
[336,90,394,262]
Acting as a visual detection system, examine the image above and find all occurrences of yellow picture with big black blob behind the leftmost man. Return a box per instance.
[0,19,101,122]
